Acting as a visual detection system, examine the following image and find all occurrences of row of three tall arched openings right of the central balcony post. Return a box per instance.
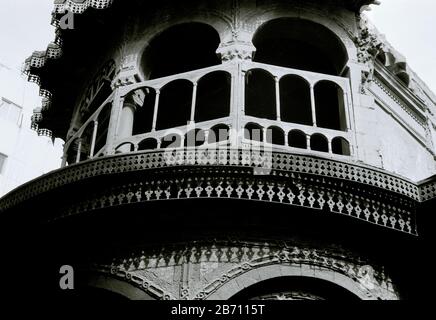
[245,69,347,131]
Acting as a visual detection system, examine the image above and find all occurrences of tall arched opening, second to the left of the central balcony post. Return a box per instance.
[156,80,193,130]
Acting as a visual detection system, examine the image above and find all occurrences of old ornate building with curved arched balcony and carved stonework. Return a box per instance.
[0,0,436,300]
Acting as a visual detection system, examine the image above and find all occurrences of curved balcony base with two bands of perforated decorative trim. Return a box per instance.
[0,149,419,235]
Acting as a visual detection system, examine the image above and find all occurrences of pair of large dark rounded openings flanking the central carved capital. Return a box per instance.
[141,17,348,80]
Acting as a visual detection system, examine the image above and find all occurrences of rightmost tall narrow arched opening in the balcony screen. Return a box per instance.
[314,81,347,131]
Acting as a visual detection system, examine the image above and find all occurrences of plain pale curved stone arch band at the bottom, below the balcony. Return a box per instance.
[208,264,375,300]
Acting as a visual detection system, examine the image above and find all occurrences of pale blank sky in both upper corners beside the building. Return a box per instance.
[0,0,436,112]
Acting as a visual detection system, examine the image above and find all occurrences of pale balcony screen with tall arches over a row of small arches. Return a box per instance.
[65,62,353,168]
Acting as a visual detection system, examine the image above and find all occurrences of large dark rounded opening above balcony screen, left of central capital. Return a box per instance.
[141,23,221,79]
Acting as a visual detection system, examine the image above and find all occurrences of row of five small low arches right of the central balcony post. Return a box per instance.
[244,123,351,156]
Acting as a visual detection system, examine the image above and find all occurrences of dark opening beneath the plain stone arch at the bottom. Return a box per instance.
[230,276,359,301]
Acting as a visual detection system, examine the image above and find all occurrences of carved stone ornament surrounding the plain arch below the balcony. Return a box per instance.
[92,239,398,300]
